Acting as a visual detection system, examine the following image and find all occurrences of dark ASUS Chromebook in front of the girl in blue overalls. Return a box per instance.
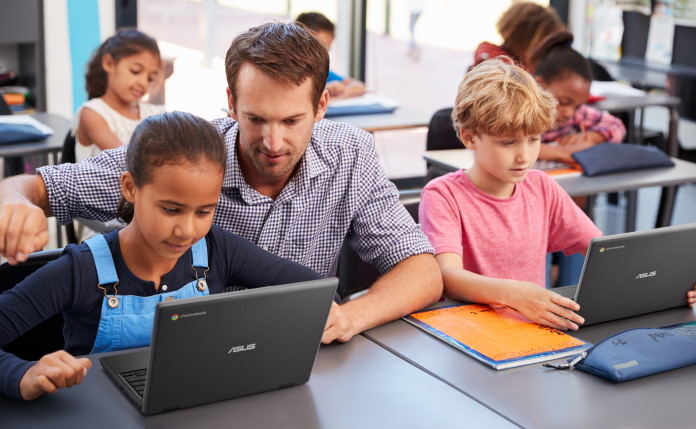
[99,277,338,414]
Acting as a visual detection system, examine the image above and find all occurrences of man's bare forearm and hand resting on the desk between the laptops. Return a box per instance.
[322,253,442,344]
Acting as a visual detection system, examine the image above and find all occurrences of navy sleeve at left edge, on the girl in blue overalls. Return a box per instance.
[0,254,73,398]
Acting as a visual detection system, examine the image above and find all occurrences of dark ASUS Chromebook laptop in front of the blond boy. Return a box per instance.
[552,223,696,327]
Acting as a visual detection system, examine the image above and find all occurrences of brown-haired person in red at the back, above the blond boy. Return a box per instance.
[474,2,566,71]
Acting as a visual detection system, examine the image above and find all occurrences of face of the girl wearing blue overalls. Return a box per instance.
[121,160,223,261]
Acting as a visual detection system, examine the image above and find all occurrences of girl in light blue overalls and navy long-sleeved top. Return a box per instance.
[0,112,320,400]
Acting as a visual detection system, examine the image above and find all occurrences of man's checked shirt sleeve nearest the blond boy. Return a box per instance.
[346,134,433,273]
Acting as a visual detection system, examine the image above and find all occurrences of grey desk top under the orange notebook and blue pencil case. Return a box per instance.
[363,307,696,429]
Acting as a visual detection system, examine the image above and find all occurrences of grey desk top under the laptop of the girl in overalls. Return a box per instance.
[0,336,516,429]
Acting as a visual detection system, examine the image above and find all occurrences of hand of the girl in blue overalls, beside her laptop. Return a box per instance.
[19,350,92,401]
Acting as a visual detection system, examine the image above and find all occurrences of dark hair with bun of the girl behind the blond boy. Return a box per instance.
[531,31,592,83]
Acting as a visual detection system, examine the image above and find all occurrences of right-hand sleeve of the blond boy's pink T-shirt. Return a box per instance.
[544,177,602,255]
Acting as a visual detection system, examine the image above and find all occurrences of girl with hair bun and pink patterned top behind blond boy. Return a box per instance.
[532,31,626,162]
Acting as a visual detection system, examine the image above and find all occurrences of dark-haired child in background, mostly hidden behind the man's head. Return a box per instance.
[295,12,365,98]
